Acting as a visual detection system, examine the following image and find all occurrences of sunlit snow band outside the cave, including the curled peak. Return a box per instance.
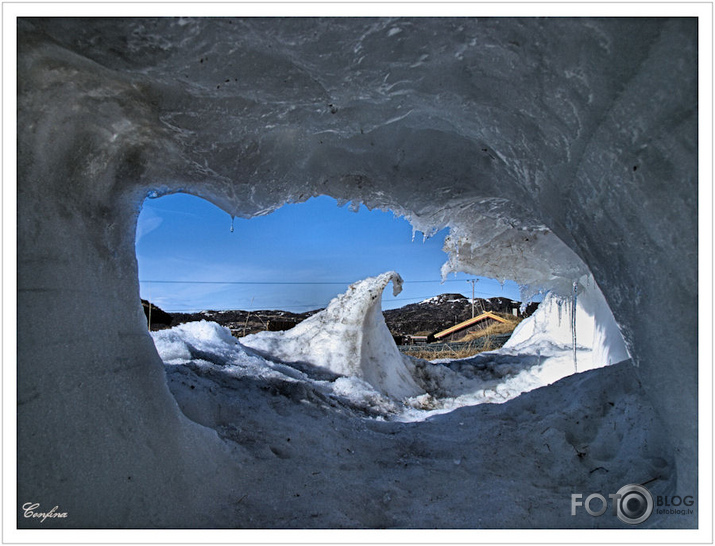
[152,272,628,421]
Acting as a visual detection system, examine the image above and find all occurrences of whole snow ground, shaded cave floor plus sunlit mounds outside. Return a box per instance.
[152,272,672,527]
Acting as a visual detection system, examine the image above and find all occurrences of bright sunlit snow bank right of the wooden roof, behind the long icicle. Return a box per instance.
[401,275,630,421]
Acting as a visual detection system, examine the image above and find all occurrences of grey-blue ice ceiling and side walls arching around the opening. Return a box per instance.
[18,18,698,526]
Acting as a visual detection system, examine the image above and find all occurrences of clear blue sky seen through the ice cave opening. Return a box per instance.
[136,194,519,312]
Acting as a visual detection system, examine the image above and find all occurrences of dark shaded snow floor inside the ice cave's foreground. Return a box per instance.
[159,352,674,528]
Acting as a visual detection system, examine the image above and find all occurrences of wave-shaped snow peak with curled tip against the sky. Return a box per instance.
[241,271,424,399]
